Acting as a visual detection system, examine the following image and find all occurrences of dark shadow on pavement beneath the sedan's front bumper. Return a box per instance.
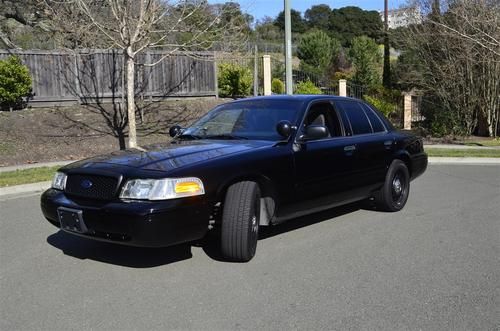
[47,231,192,268]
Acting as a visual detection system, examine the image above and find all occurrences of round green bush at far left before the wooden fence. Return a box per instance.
[0,56,31,109]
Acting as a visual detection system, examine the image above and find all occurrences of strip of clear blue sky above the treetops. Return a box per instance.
[209,0,406,20]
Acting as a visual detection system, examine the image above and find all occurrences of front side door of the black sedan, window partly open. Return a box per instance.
[280,101,355,218]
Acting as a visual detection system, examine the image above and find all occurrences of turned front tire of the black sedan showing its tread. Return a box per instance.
[221,181,260,262]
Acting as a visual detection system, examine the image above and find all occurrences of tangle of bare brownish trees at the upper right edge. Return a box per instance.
[399,0,500,136]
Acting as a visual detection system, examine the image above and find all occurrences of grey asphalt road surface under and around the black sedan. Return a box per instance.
[0,165,500,330]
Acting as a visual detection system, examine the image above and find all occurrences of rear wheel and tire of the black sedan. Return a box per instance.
[375,160,410,212]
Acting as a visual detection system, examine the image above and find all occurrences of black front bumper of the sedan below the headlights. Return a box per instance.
[41,189,212,247]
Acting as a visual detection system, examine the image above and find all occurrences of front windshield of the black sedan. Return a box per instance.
[180,100,300,141]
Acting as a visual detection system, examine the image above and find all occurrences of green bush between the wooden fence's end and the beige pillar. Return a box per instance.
[218,63,253,98]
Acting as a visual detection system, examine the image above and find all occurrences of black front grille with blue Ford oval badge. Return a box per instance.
[64,175,119,200]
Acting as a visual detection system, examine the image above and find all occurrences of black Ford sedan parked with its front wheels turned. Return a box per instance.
[41,96,427,261]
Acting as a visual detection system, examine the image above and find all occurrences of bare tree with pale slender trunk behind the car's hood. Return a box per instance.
[42,0,246,148]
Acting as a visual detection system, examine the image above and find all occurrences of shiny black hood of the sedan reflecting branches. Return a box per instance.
[64,140,273,171]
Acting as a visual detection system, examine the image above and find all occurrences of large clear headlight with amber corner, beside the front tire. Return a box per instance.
[120,177,205,200]
